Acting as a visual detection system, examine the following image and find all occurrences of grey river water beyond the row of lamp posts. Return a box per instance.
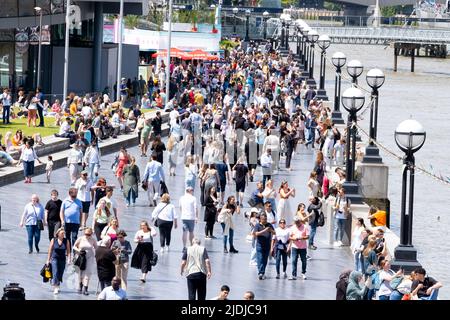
[315,44,450,299]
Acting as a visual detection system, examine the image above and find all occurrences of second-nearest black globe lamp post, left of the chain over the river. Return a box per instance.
[342,87,366,203]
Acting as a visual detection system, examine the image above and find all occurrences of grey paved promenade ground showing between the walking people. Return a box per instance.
[0,141,352,300]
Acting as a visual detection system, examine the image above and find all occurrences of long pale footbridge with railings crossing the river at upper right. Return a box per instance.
[314,27,450,45]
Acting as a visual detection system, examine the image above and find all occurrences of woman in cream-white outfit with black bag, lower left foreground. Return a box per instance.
[73,228,97,295]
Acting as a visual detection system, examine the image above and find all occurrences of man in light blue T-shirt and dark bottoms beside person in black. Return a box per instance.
[59,188,83,246]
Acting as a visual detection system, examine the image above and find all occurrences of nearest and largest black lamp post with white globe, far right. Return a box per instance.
[392,119,426,273]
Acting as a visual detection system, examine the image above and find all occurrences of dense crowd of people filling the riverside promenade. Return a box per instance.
[7,39,439,300]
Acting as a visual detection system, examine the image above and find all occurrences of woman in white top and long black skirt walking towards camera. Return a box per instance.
[131,221,156,283]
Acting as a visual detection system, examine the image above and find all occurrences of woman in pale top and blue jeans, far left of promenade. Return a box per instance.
[20,194,44,253]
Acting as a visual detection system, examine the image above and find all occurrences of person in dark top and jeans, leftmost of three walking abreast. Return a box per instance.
[252,213,275,280]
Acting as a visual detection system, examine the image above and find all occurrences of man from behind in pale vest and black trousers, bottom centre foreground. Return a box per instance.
[181,238,211,300]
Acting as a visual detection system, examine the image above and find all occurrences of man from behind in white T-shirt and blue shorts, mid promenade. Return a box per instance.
[179,186,198,250]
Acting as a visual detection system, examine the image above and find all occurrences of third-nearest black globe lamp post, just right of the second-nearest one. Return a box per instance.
[363,69,385,163]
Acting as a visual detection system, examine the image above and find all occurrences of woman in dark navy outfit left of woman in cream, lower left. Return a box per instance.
[47,228,71,294]
